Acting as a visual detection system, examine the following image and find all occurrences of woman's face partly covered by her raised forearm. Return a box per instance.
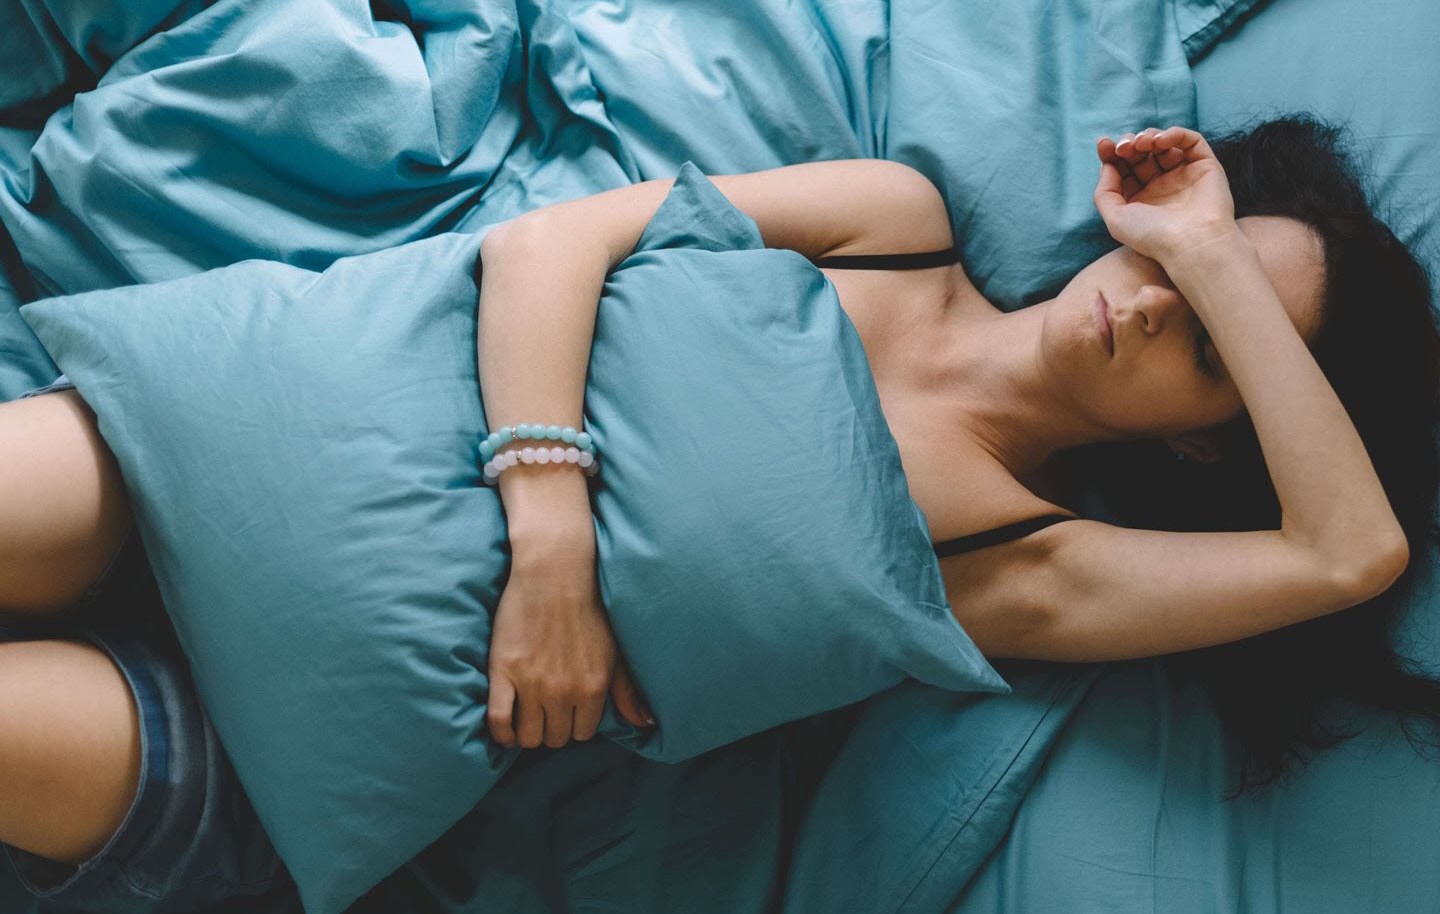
[1041,216,1325,451]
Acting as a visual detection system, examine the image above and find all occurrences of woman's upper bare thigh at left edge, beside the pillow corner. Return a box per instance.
[0,390,132,619]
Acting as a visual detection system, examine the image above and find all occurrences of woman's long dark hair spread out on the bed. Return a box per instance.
[1064,112,1440,799]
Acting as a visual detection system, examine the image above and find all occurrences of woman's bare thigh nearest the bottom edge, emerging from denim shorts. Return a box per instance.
[0,636,140,865]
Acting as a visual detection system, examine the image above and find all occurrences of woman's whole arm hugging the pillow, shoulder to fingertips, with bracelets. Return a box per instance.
[477,160,953,748]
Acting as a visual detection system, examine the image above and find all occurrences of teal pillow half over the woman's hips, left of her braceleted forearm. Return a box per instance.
[22,235,516,913]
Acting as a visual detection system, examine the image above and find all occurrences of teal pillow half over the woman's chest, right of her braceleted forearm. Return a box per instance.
[585,163,1009,761]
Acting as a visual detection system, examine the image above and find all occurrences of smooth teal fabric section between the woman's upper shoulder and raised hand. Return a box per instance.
[883,0,1195,311]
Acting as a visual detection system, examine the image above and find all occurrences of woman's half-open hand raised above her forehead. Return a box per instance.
[1094,127,1237,262]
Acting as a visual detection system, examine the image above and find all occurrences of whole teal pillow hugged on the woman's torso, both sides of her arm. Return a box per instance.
[22,163,1008,914]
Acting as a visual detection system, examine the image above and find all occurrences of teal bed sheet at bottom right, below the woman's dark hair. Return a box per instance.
[944,661,1440,914]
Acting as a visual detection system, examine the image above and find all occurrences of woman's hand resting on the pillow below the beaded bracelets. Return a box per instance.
[487,538,652,748]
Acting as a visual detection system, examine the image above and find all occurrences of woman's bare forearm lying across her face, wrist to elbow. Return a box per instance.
[1162,226,1404,570]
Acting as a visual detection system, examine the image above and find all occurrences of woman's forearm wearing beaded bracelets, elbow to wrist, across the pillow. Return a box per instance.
[477,226,609,561]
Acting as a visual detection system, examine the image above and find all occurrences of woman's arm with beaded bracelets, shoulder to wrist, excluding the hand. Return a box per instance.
[477,158,953,551]
